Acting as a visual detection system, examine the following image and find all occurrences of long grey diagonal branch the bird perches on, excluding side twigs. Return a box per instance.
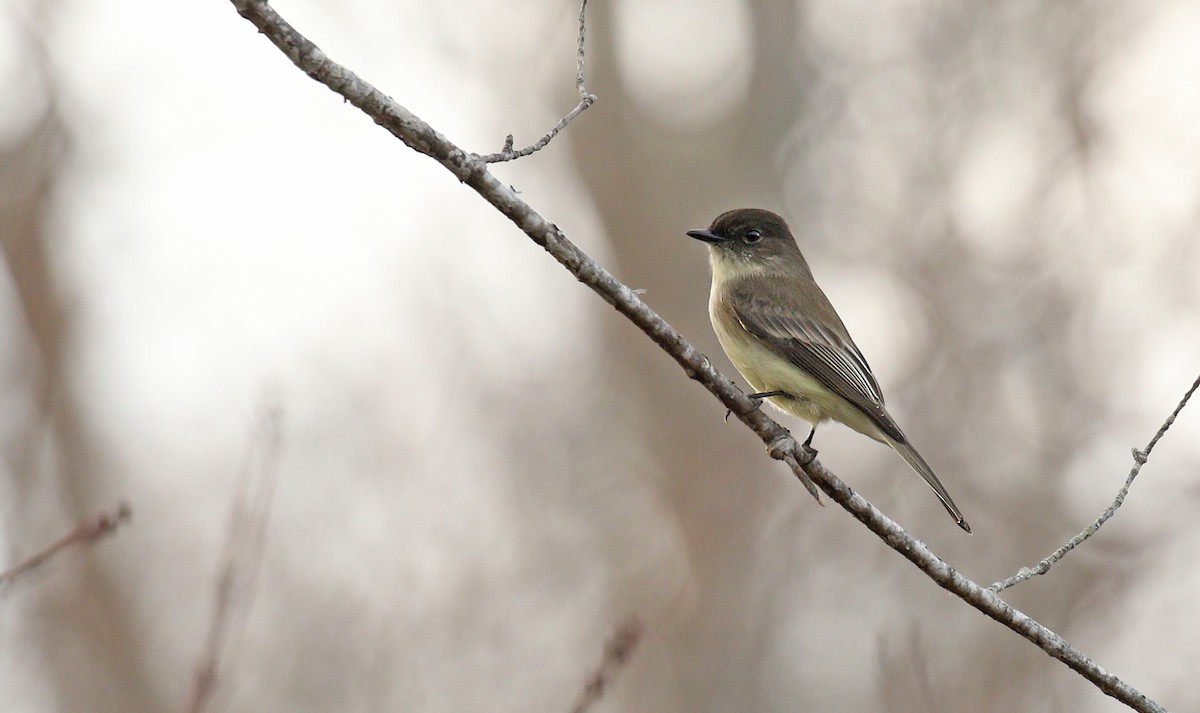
[223,0,1163,713]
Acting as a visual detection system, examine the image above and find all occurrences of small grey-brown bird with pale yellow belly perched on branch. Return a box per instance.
[688,208,971,533]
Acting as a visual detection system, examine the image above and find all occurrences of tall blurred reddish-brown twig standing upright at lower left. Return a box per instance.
[187,397,283,713]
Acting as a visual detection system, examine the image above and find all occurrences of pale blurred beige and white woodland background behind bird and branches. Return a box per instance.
[0,0,1200,713]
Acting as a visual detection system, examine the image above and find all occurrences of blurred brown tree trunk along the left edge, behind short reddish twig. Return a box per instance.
[0,27,161,713]
